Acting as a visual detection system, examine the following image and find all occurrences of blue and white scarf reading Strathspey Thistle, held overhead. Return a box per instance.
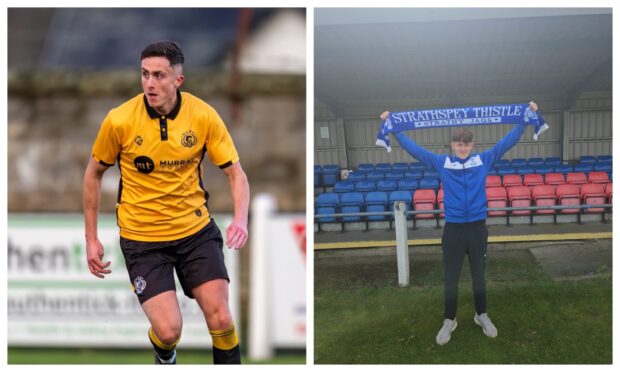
[376,104,549,152]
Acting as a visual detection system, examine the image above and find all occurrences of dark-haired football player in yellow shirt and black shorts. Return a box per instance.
[83,41,250,364]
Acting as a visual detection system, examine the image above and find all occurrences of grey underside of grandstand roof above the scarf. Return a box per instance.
[314,8,612,108]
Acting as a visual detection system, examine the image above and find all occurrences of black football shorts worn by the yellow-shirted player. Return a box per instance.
[121,219,230,304]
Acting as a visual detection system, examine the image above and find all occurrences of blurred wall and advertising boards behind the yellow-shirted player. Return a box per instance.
[7,8,306,364]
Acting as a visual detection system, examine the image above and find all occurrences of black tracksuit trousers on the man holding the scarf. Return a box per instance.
[441,220,489,319]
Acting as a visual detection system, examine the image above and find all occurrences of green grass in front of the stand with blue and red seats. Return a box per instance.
[314,247,612,364]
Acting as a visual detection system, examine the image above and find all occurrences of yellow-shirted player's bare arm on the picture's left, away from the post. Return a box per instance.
[82,157,111,278]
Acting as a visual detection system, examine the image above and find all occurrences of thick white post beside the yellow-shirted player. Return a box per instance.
[248,194,276,360]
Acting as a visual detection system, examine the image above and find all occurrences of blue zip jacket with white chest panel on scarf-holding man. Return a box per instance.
[394,124,527,223]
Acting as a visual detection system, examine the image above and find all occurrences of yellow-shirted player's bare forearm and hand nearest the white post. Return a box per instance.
[223,162,250,249]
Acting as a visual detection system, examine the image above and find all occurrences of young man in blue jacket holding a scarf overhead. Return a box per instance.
[381,102,538,345]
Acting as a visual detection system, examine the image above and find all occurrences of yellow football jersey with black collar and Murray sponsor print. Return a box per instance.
[93,92,239,241]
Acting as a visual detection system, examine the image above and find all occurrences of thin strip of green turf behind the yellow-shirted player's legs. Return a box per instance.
[8,347,306,364]
